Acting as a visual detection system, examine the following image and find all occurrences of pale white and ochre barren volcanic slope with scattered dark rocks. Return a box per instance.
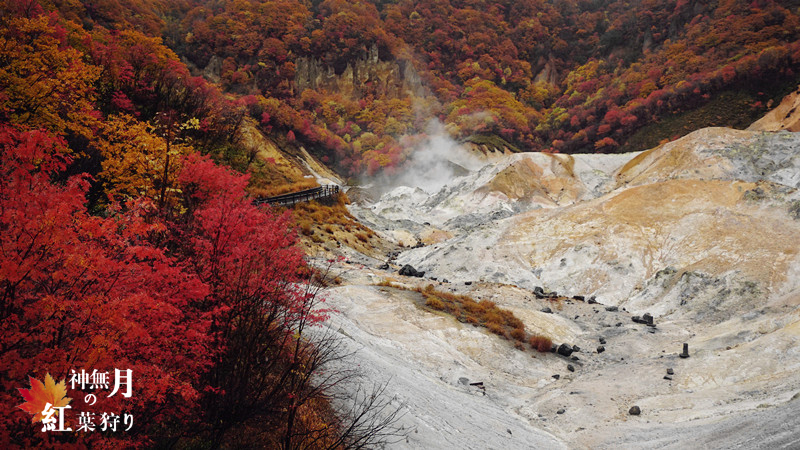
[330,121,800,448]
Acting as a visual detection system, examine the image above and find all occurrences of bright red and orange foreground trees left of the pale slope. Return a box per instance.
[0,2,360,448]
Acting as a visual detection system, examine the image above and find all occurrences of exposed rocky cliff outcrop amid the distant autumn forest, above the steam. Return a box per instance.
[295,46,424,98]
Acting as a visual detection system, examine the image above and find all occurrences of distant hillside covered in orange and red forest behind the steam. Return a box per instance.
[168,0,800,173]
